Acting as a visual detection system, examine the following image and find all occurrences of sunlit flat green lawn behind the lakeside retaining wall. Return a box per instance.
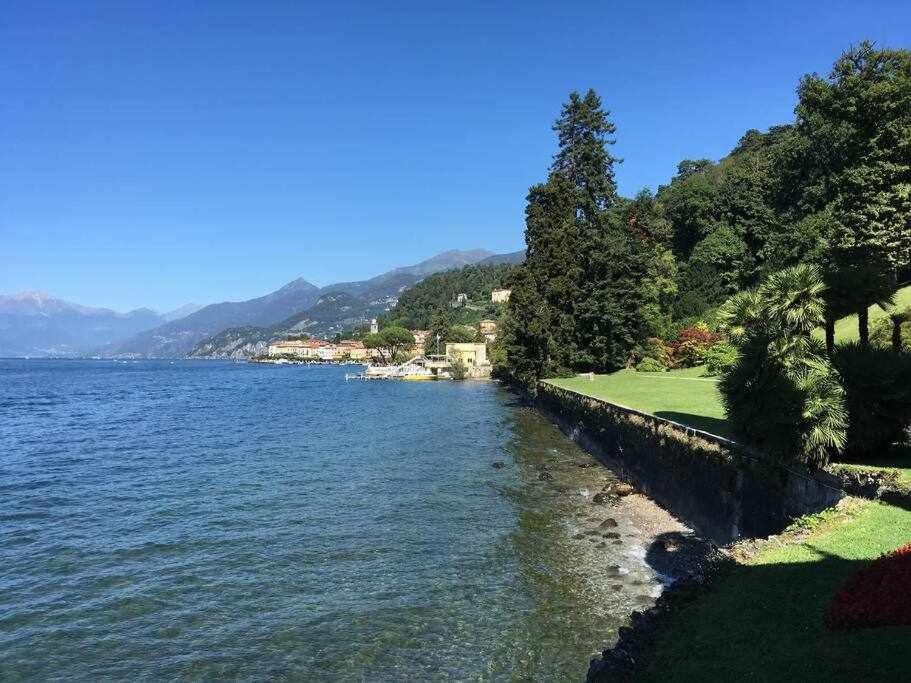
[548,368,731,436]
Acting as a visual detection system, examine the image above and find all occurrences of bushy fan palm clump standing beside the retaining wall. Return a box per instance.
[720,265,847,465]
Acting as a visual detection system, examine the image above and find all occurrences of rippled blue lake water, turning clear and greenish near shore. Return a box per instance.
[0,360,658,681]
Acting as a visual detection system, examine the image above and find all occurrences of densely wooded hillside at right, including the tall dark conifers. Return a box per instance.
[506,42,911,385]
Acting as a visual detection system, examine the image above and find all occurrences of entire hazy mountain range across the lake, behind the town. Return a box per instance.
[0,249,524,358]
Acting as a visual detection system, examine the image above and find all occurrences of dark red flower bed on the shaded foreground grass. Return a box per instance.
[826,543,911,630]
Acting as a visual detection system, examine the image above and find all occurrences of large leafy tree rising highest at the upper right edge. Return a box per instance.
[796,42,911,267]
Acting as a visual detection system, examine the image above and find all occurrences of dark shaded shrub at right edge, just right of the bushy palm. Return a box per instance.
[833,343,911,462]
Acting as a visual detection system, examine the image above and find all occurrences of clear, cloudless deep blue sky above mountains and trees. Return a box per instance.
[0,0,911,310]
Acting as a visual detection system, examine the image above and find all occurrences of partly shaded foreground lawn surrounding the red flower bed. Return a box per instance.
[642,502,911,681]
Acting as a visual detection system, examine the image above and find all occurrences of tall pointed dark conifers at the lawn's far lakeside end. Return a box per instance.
[507,91,636,385]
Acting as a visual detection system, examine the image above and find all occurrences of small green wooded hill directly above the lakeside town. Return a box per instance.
[384,263,517,330]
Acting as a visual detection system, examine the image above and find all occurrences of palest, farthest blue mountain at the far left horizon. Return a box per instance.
[0,292,200,357]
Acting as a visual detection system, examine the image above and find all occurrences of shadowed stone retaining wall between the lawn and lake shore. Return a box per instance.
[532,382,844,544]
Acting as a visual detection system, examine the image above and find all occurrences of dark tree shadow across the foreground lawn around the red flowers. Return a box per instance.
[637,533,911,681]
